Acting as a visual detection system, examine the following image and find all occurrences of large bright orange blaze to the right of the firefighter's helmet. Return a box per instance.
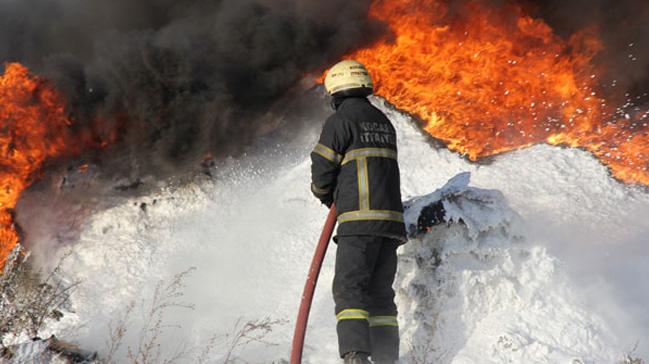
[348,0,649,185]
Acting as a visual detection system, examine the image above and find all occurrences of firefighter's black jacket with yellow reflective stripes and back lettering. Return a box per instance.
[311,97,406,242]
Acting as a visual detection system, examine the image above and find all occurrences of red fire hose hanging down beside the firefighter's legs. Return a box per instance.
[291,205,336,364]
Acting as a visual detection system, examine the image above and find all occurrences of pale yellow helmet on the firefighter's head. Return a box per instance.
[325,60,374,96]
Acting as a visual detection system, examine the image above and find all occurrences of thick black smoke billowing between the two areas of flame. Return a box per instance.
[0,0,385,176]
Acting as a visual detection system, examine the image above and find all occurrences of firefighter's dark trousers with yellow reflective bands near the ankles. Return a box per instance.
[333,235,399,363]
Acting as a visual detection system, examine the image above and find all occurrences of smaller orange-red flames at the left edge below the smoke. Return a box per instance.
[0,63,78,269]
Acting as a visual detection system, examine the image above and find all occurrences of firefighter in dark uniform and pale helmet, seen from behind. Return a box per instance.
[311,60,406,364]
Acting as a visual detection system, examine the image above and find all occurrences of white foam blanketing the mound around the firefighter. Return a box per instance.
[21,99,649,364]
